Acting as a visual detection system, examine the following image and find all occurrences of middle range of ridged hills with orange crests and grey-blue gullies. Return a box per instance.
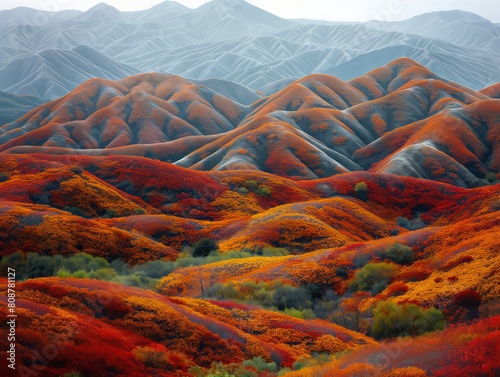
[0,58,500,187]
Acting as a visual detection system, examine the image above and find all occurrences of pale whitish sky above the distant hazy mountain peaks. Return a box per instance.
[0,0,500,22]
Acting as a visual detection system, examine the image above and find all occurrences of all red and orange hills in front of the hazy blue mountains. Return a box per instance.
[0,59,500,377]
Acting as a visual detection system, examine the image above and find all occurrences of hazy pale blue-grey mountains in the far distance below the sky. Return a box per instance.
[0,0,500,99]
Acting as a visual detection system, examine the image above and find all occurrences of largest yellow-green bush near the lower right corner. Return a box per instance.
[371,301,446,339]
